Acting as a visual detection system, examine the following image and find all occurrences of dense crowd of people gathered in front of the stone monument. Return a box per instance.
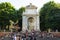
[0,31,59,40]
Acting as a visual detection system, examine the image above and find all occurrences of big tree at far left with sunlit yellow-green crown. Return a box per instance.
[0,2,15,29]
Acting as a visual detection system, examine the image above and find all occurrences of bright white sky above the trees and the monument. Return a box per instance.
[0,0,60,9]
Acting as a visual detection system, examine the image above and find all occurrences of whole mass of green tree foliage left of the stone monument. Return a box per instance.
[0,2,25,29]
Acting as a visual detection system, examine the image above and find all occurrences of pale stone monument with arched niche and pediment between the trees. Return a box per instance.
[22,3,40,31]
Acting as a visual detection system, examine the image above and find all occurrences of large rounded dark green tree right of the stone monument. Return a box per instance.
[40,1,60,30]
